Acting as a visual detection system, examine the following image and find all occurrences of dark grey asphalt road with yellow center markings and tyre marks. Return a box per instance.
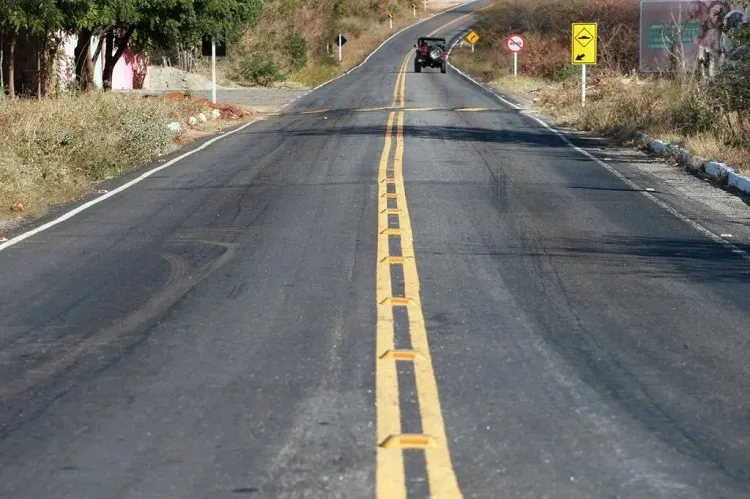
[0,2,750,499]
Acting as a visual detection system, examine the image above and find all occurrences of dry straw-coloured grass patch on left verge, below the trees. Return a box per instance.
[0,93,254,222]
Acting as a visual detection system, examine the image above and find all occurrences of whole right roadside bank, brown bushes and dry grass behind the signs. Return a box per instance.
[453,0,750,171]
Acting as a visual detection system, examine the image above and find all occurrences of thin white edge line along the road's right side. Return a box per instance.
[448,31,750,261]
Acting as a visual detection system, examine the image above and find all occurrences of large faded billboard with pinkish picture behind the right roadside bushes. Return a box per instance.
[639,0,750,72]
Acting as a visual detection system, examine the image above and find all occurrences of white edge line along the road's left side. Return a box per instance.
[0,0,479,251]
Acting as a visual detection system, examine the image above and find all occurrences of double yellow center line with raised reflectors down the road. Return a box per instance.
[375,4,494,499]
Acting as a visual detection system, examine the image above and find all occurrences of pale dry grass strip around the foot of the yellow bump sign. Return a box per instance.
[453,66,750,174]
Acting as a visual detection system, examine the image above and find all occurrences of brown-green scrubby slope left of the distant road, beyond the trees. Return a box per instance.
[224,0,445,86]
